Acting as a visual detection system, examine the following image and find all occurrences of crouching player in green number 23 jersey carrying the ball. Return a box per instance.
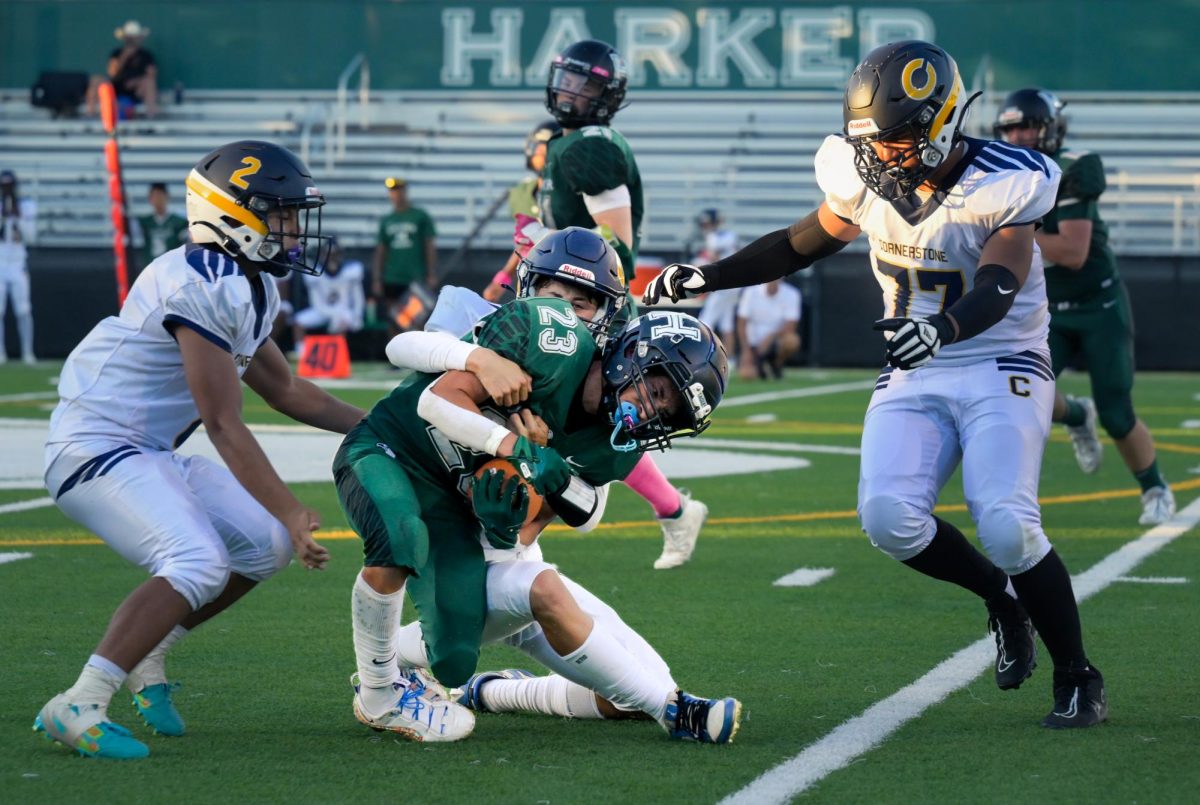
[334,226,737,740]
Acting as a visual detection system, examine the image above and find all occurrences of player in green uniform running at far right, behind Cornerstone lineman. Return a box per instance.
[995,89,1175,525]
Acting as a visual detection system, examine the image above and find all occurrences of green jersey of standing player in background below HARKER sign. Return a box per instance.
[539,126,644,277]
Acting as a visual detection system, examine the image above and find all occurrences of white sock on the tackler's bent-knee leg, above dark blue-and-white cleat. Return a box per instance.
[552,621,676,720]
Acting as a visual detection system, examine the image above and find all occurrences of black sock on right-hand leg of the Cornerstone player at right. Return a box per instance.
[1012,548,1087,671]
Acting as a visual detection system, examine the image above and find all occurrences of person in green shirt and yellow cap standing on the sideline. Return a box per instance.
[371,176,438,319]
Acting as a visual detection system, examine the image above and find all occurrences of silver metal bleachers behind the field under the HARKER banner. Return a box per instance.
[0,90,1200,256]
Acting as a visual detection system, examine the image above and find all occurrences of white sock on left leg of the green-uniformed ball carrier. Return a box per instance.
[350,573,404,714]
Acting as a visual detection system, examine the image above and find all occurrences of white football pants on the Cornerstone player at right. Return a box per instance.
[858,352,1055,576]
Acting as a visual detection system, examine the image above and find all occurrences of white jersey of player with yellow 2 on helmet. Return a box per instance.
[46,244,280,465]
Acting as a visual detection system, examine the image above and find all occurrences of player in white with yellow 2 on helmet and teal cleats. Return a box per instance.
[34,140,364,758]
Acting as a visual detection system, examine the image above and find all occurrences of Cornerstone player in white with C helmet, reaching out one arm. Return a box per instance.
[646,41,1108,727]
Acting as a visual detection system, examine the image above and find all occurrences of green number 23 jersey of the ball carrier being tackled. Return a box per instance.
[366,299,596,493]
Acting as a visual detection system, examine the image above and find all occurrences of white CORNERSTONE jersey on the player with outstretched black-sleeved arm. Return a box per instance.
[816,136,1061,366]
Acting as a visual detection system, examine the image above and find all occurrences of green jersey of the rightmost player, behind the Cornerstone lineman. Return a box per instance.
[1043,151,1118,305]
